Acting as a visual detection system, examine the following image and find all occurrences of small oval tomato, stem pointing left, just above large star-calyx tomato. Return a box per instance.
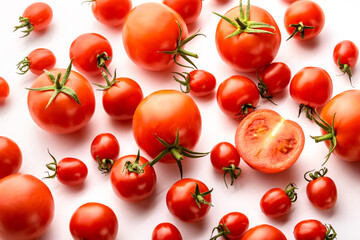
[17,48,56,75]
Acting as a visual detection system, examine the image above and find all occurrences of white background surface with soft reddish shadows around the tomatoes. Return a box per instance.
[0,0,360,240]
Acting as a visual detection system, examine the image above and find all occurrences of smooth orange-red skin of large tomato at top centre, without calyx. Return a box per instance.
[122,2,188,71]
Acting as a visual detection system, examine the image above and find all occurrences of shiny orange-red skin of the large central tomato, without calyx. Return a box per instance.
[133,90,201,163]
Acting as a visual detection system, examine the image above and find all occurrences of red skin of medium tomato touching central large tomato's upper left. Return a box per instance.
[102,78,144,120]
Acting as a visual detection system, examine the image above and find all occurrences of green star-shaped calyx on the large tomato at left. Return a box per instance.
[26,59,81,109]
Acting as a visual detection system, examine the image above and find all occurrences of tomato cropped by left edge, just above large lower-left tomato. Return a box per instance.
[0,136,22,179]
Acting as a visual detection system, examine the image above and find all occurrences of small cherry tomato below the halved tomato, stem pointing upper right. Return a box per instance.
[260,183,297,218]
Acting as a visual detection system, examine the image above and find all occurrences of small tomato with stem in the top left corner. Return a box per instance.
[14,2,53,37]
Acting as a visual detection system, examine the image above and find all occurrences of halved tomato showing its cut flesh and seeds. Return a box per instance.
[235,109,305,173]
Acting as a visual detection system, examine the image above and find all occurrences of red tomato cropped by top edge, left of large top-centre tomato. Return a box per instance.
[89,0,132,27]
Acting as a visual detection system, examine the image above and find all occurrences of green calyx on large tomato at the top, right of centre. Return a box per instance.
[213,0,276,38]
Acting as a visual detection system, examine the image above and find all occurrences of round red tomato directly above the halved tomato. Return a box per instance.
[216,75,260,120]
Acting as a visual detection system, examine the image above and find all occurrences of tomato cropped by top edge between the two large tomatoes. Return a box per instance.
[162,0,202,24]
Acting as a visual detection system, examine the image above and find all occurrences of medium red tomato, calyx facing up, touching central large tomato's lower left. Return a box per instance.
[110,155,156,202]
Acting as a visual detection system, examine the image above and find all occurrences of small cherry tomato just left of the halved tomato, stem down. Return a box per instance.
[210,142,241,186]
